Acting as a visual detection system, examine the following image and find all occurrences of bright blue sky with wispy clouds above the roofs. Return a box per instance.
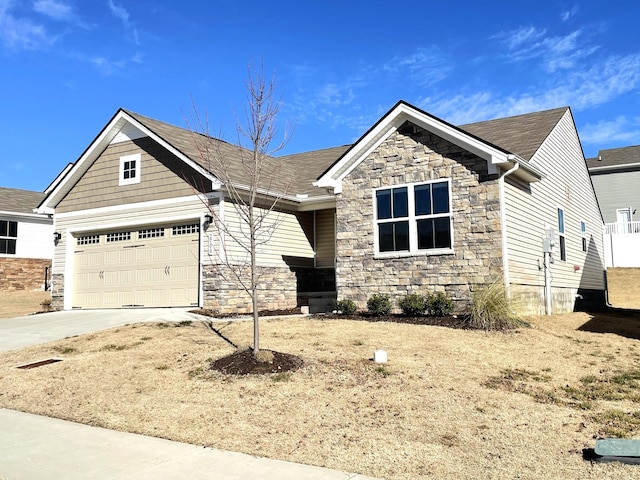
[0,0,640,190]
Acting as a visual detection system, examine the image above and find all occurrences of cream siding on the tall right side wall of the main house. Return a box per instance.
[505,110,604,290]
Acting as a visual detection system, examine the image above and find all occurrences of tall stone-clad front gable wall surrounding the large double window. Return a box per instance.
[336,124,502,310]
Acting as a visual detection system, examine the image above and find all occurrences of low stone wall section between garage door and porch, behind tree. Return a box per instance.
[202,265,297,314]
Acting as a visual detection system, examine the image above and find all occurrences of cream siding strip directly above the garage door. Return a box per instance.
[53,196,205,274]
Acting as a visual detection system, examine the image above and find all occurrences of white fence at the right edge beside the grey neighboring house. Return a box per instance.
[603,222,640,268]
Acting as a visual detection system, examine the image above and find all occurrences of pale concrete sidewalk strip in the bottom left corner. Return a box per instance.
[0,409,374,480]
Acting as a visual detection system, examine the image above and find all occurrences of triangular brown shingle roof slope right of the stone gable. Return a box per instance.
[460,107,569,160]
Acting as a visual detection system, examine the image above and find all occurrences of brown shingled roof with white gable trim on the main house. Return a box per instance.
[40,101,568,213]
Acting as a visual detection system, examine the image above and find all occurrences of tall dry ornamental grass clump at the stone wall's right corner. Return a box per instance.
[469,279,526,330]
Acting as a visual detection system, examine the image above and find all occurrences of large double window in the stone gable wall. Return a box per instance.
[375,180,453,253]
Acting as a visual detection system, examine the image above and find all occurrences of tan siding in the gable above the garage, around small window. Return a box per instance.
[56,137,204,213]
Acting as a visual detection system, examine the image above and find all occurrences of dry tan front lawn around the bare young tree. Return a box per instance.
[0,313,640,479]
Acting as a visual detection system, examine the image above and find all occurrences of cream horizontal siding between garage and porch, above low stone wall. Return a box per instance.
[212,201,315,267]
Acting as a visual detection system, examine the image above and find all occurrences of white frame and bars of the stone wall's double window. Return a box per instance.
[372,178,455,258]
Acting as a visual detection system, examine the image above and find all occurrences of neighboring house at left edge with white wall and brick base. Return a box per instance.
[0,187,53,291]
